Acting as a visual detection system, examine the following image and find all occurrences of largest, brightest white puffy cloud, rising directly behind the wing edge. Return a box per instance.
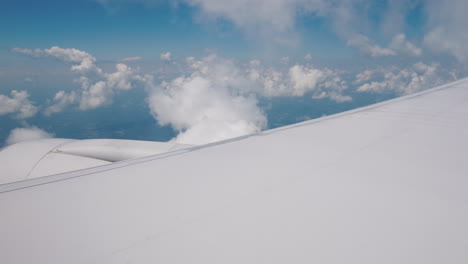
[148,56,267,145]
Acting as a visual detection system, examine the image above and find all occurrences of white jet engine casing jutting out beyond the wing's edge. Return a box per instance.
[0,138,192,185]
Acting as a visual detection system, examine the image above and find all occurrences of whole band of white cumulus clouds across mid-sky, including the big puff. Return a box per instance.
[9,45,462,145]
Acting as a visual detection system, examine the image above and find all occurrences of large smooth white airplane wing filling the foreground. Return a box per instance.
[0,79,468,264]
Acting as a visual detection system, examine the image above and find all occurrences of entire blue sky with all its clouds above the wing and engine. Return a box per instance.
[0,0,468,144]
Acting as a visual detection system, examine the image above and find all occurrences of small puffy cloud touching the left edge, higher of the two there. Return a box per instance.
[0,90,38,119]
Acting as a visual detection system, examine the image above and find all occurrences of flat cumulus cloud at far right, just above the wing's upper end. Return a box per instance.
[357,62,454,95]
